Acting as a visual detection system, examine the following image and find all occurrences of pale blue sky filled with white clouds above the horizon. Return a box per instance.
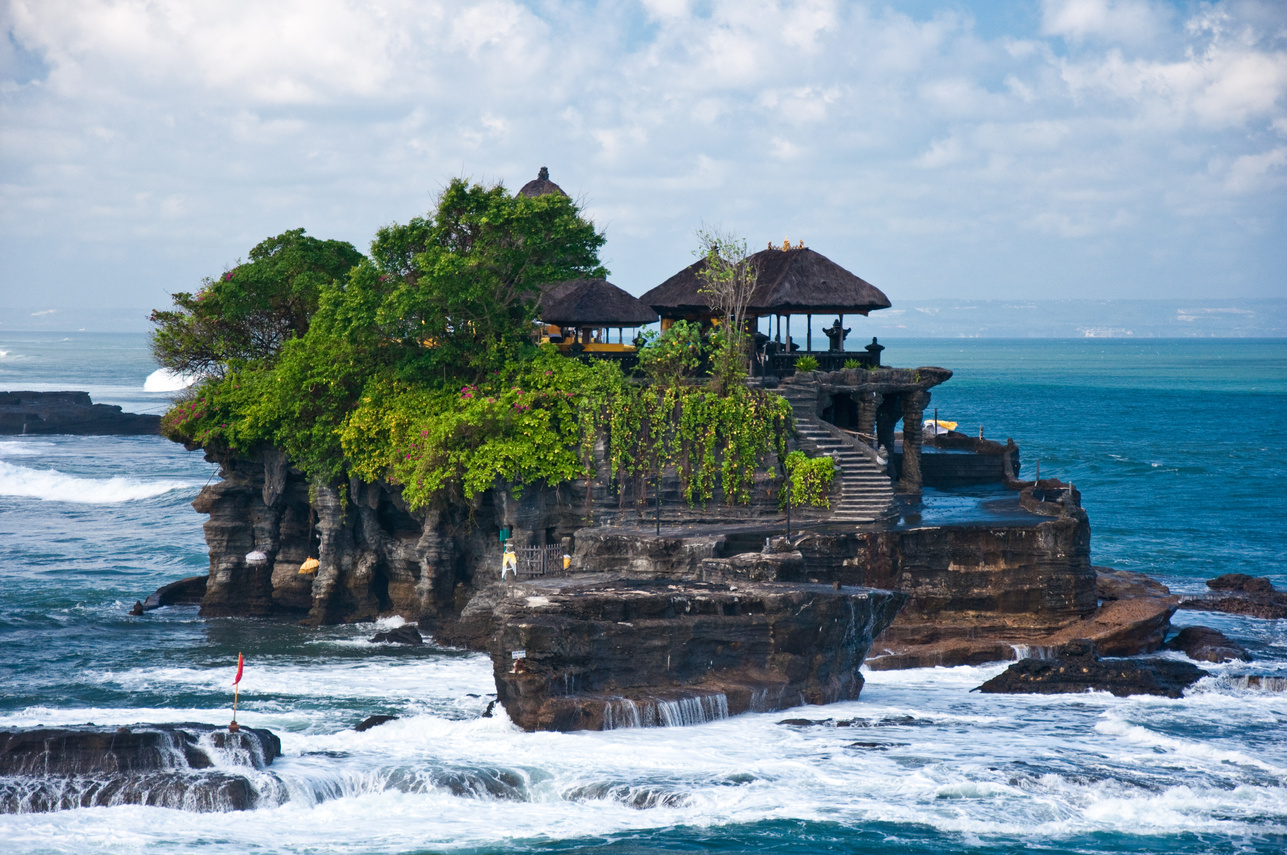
[0,0,1287,330]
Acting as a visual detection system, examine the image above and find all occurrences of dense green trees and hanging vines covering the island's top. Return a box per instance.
[154,180,790,509]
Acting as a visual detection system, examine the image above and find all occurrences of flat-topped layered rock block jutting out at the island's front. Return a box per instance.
[490,577,906,730]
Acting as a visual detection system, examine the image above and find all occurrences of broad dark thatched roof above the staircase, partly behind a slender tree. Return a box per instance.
[640,247,889,317]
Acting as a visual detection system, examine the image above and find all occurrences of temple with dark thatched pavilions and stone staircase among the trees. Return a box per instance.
[519,167,957,502]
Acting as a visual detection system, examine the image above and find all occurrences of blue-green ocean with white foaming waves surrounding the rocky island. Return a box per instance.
[0,332,1287,855]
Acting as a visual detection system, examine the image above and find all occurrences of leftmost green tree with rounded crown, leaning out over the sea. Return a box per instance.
[152,229,363,377]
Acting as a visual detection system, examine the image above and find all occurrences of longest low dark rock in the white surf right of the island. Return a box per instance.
[978,639,1207,698]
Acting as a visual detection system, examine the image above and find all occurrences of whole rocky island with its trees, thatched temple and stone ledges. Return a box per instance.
[139,169,1230,730]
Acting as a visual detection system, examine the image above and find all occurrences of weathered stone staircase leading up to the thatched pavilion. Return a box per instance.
[777,384,897,523]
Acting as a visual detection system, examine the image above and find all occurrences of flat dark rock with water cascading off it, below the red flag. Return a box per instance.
[0,724,282,814]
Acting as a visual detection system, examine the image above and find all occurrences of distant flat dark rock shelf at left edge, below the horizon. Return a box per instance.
[0,391,161,435]
